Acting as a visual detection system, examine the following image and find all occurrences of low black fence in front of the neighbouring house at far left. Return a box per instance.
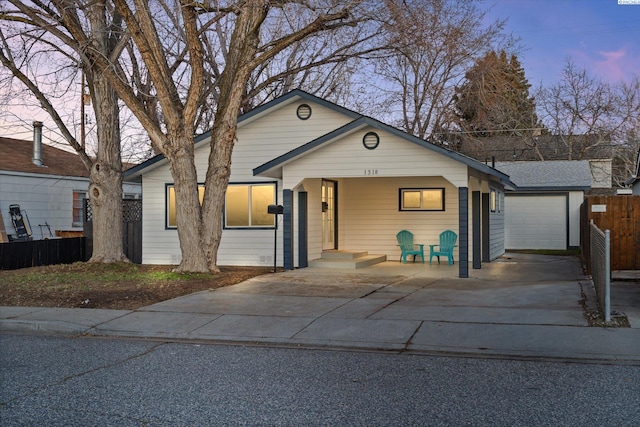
[0,237,87,270]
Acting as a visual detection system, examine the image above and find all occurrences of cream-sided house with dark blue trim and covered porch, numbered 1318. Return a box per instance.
[125,90,513,277]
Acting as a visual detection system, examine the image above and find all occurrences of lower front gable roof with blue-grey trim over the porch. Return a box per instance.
[253,116,515,186]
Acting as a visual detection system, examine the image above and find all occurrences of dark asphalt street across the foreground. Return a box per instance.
[0,334,640,427]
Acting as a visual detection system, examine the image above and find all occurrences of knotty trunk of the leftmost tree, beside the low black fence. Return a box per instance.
[89,75,128,263]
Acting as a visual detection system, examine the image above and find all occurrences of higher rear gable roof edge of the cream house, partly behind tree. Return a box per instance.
[124,89,360,181]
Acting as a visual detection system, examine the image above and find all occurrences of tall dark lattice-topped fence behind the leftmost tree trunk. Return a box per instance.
[84,199,142,264]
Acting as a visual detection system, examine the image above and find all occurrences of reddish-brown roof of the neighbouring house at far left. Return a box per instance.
[0,137,89,178]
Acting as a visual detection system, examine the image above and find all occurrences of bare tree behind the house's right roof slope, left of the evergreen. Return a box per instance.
[375,0,508,139]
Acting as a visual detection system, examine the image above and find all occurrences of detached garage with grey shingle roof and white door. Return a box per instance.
[496,160,599,250]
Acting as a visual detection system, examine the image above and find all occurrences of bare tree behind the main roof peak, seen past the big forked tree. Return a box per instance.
[196,1,383,131]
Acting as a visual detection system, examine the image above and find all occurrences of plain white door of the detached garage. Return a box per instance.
[505,195,567,249]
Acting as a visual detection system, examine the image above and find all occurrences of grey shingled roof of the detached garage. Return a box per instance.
[496,160,591,191]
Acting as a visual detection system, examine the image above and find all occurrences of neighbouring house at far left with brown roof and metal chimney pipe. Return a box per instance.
[0,128,140,240]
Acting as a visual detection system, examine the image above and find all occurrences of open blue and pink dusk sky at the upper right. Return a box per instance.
[482,0,640,88]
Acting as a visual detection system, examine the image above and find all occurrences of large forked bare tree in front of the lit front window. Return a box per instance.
[60,0,377,271]
